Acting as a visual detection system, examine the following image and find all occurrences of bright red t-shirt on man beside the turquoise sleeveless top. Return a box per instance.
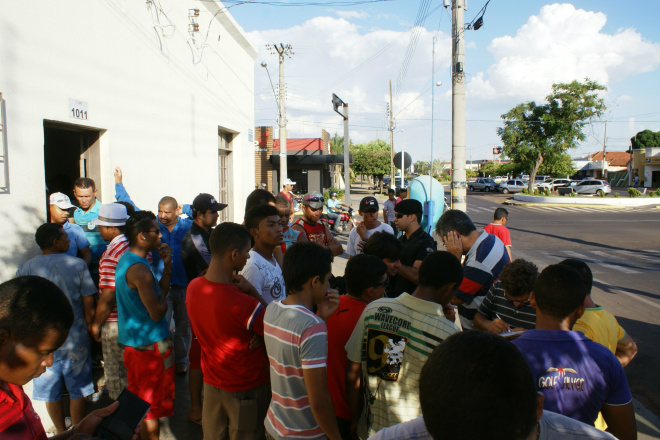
[186,277,268,393]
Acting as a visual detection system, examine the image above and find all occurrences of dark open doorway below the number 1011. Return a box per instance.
[44,120,102,212]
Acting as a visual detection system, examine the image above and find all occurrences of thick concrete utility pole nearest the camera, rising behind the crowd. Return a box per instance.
[451,0,467,212]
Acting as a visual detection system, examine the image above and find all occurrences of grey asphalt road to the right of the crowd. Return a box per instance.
[467,193,660,434]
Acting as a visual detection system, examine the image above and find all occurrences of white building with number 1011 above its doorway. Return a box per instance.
[0,0,257,281]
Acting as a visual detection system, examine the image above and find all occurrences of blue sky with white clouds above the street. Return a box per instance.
[225,0,660,160]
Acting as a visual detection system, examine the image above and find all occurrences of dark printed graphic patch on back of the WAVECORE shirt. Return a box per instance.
[367,329,408,382]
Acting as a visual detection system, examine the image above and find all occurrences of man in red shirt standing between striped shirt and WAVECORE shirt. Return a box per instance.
[326,254,388,438]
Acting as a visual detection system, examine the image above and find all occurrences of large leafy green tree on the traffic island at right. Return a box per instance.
[497,78,607,191]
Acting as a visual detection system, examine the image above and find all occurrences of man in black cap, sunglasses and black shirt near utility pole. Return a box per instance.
[388,199,437,297]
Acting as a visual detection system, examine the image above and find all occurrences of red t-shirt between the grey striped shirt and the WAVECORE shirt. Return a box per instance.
[325,295,367,420]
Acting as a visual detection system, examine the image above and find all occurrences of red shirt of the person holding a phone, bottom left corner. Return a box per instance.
[0,383,47,440]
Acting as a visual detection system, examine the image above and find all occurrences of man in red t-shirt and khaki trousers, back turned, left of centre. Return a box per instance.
[186,222,271,440]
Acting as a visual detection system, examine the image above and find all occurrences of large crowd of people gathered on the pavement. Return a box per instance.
[0,172,637,440]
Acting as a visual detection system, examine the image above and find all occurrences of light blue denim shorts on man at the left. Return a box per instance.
[32,347,94,402]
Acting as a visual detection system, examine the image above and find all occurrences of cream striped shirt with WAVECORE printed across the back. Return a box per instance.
[346,293,460,438]
